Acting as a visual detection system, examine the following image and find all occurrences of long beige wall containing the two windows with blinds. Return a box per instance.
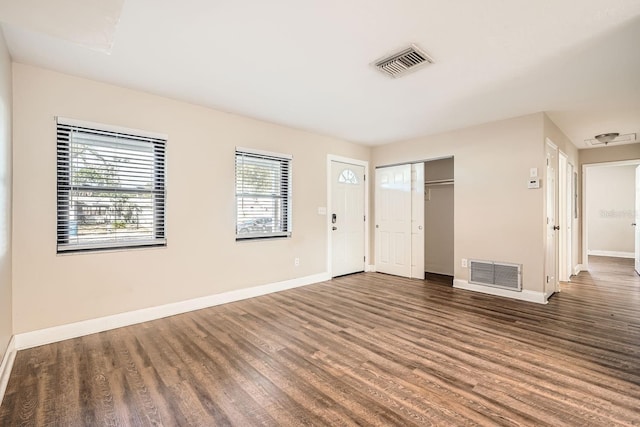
[13,64,370,333]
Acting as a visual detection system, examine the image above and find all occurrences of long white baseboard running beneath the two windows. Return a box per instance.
[15,273,331,350]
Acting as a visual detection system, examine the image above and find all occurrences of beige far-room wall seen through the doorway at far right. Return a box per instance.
[586,165,637,254]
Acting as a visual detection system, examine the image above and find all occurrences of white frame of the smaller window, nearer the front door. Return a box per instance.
[234,147,293,242]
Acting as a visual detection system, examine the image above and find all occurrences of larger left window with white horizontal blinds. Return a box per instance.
[57,118,166,253]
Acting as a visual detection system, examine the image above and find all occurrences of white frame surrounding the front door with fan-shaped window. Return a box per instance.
[318,154,373,275]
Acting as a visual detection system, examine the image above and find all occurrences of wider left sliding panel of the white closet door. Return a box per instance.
[375,164,410,277]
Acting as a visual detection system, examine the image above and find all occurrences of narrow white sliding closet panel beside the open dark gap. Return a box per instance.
[411,163,424,279]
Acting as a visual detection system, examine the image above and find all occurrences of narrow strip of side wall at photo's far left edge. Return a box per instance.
[0,30,13,360]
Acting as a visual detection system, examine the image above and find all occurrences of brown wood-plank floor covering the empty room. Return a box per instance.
[0,257,640,426]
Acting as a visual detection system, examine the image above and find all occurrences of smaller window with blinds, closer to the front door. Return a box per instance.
[236,148,291,240]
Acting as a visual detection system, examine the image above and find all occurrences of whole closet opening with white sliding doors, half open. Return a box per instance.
[375,157,454,279]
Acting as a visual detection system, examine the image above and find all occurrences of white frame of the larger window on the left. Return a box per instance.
[56,117,168,255]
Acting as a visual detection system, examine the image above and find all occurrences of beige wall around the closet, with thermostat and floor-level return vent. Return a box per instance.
[372,113,545,292]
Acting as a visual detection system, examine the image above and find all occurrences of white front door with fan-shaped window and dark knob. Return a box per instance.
[330,161,365,277]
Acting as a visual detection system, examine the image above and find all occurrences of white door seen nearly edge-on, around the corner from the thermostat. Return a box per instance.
[545,143,560,296]
